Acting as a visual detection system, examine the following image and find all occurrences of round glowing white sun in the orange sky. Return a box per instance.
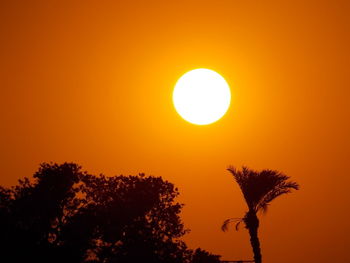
[173,68,231,125]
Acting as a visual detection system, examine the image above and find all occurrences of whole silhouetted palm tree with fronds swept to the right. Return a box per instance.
[222,167,299,263]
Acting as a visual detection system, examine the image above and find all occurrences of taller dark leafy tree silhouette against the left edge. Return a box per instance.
[0,164,82,262]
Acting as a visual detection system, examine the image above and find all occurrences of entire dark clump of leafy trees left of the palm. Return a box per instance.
[0,163,221,263]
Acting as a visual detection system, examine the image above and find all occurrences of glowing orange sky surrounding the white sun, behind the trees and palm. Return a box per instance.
[0,0,350,263]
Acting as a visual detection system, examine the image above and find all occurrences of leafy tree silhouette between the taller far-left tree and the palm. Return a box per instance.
[79,174,188,263]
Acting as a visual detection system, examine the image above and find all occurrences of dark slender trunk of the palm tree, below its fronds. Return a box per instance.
[245,211,262,263]
